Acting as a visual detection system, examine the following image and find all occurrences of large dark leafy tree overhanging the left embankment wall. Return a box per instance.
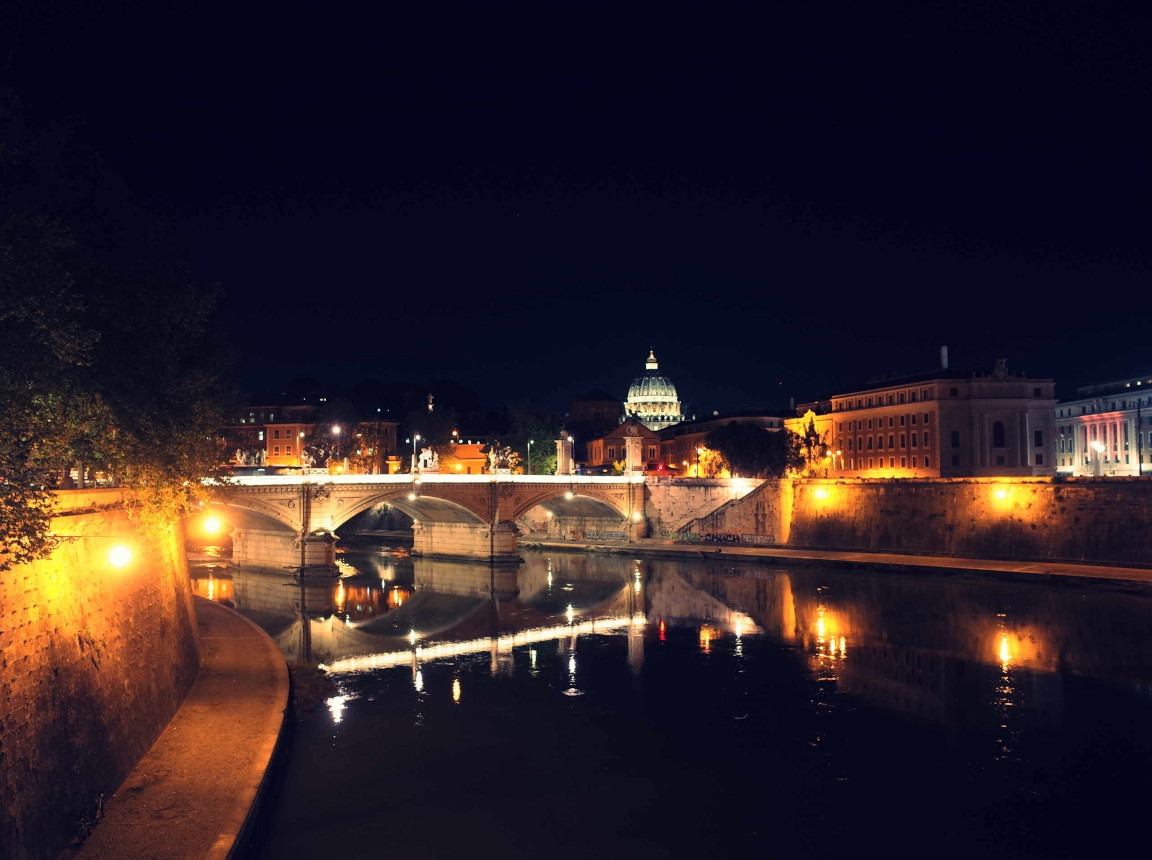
[0,100,227,568]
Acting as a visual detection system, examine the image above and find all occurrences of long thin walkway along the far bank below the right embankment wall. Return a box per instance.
[521,538,1152,586]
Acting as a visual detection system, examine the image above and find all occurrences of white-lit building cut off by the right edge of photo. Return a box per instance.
[1055,376,1152,475]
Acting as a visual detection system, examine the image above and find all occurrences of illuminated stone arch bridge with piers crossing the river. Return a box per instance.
[213,472,649,572]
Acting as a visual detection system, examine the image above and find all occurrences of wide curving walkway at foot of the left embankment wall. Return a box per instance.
[71,598,288,860]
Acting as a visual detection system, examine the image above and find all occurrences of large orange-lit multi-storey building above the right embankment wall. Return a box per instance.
[785,361,1056,478]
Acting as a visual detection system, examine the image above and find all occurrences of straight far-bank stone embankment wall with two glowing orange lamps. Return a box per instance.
[789,478,1152,564]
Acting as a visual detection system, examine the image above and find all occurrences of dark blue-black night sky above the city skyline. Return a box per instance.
[0,0,1152,412]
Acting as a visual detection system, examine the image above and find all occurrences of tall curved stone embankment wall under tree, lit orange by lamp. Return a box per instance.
[0,490,199,860]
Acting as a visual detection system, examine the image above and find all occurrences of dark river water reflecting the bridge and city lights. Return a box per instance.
[194,551,1152,857]
